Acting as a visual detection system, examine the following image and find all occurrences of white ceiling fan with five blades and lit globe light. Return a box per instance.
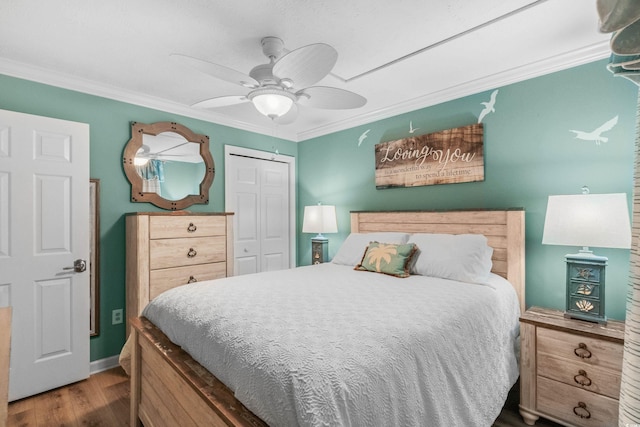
[171,37,367,124]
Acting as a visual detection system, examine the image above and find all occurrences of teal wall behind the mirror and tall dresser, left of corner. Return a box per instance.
[0,75,297,361]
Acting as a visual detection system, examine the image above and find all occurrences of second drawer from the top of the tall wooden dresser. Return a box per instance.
[149,236,227,270]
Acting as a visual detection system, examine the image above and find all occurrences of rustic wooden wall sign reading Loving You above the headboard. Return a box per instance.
[375,123,484,189]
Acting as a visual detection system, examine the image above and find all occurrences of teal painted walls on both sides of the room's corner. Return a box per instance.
[0,56,637,360]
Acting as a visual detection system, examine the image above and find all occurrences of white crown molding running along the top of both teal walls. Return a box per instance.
[0,40,611,142]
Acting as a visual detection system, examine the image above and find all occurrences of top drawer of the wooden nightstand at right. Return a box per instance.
[537,328,623,371]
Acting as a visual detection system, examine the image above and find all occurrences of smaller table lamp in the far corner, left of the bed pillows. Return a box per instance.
[302,203,338,264]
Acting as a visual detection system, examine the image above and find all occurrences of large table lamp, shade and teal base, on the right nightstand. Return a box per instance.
[542,187,631,323]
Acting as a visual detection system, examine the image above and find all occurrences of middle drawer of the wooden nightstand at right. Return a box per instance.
[538,354,620,399]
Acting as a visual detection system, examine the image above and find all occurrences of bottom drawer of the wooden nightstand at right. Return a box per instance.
[536,377,618,427]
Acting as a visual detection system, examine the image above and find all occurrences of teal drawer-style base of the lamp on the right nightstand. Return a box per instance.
[564,253,608,324]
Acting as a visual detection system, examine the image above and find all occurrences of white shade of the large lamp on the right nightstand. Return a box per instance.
[542,193,631,249]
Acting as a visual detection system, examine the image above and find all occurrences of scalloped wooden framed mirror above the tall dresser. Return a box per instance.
[122,122,215,210]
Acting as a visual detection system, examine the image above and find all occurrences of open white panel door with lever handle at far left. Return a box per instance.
[0,110,89,401]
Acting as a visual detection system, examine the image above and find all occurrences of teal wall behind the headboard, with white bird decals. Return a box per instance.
[298,61,637,319]
